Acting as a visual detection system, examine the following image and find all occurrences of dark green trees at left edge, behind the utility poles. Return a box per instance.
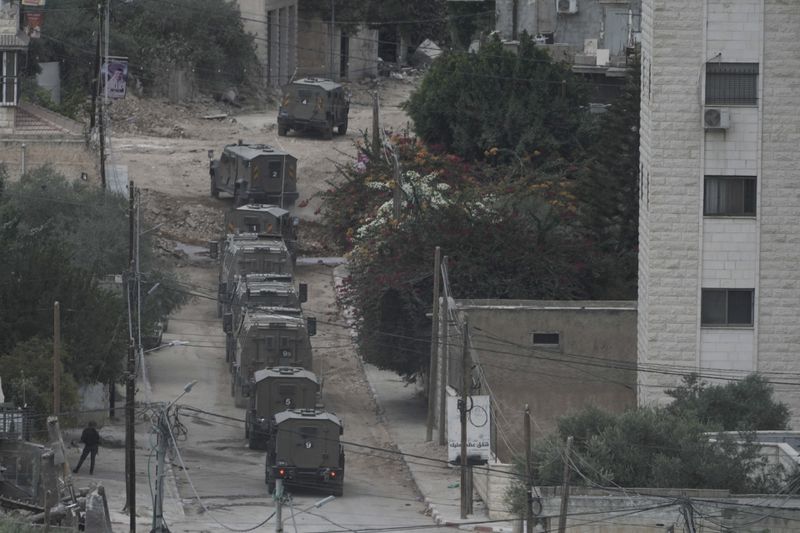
[0,167,186,426]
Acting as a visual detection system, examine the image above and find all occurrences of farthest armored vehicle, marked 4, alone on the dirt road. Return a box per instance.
[278,78,350,139]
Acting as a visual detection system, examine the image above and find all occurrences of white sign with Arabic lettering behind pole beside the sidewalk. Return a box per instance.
[447,395,492,464]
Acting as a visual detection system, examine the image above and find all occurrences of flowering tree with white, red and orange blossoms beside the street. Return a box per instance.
[346,167,586,379]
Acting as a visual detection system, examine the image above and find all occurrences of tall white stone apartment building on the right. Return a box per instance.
[638,0,800,427]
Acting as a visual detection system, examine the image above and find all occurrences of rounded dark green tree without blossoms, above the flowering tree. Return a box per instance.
[406,33,591,162]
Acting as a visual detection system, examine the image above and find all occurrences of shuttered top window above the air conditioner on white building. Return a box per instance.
[706,62,758,105]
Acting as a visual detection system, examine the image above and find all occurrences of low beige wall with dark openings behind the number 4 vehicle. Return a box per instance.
[297,18,378,80]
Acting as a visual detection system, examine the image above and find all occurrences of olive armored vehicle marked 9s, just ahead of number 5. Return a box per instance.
[231,307,317,407]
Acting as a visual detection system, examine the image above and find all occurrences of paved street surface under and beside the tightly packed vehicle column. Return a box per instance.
[129,252,446,532]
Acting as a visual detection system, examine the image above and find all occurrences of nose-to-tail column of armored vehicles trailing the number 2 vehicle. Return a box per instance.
[209,197,344,496]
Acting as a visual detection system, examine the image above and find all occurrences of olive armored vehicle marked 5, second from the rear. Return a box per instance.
[244,366,319,450]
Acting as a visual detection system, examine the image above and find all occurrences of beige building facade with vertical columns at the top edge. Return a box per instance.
[237,0,297,87]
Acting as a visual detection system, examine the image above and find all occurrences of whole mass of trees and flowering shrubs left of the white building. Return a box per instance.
[322,36,639,379]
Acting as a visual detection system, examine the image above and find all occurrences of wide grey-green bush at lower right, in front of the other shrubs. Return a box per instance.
[506,407,786,513]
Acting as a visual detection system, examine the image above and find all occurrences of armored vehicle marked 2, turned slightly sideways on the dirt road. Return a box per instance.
[209,141,298,208]
